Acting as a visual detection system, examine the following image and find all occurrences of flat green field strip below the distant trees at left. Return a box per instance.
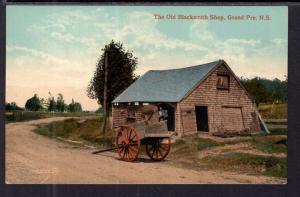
[5,111,97,123]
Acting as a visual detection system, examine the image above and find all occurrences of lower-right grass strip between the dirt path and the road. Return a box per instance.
[199,153,287,178]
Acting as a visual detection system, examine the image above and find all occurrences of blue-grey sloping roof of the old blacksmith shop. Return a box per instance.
[113,60,222,103]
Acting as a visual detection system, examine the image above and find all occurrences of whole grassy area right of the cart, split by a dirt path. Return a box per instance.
[170,134,287,178]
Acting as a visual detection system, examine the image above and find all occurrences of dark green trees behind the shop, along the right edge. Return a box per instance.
[241,76,288,105]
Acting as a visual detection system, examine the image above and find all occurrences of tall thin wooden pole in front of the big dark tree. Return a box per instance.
[102,50,108,135]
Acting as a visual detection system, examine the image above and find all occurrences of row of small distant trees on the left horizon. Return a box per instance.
[5,92,82,112]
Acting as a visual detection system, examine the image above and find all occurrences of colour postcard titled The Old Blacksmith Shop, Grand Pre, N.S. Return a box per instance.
[5,5,288,184]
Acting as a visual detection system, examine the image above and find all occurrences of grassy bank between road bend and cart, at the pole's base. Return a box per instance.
[35,118,114,147]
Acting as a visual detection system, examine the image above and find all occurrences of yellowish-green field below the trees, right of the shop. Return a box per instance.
[258,103,287,119]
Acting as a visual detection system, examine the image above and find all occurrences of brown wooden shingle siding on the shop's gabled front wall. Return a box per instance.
[176,65,261,134]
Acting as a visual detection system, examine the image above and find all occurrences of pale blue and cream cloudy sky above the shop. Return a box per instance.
[6,5,288,110]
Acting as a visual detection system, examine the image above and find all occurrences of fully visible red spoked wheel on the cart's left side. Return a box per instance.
[116,126,141,161]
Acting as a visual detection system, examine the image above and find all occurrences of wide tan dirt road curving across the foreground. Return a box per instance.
[6,117,284,184]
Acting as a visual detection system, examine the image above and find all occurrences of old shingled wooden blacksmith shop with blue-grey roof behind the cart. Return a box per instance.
[112,60,261,135]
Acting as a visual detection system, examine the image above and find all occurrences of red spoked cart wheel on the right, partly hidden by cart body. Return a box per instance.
[146,137,171,161]
